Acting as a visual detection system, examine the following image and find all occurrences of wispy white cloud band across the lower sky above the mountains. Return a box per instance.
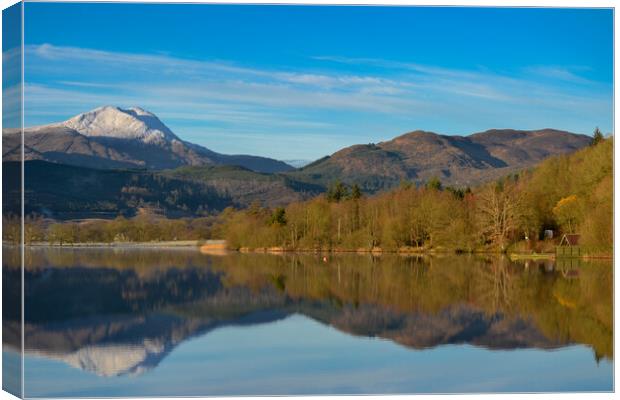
[25,44,612,158]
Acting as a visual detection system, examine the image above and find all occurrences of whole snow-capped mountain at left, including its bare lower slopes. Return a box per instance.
[2,106,294,172]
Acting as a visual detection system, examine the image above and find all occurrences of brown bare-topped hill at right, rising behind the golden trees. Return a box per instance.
[289,129,591,193]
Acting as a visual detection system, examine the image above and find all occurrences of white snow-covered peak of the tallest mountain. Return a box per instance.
[63,106,179,143]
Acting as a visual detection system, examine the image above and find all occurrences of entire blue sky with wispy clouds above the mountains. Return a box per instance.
[15,3,613,159]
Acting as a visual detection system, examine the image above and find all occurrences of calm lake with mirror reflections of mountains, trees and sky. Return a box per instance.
[3,248,613,397]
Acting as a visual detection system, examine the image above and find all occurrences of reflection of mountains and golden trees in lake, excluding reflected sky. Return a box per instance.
[3,247,613,394]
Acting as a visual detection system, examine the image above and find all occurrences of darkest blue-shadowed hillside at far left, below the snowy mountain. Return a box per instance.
[3,160,231,219]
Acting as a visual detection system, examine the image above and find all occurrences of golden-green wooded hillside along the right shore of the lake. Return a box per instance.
[220,139,613,254]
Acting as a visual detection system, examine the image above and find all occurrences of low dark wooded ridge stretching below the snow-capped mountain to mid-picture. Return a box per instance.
[3,160,322,219]
